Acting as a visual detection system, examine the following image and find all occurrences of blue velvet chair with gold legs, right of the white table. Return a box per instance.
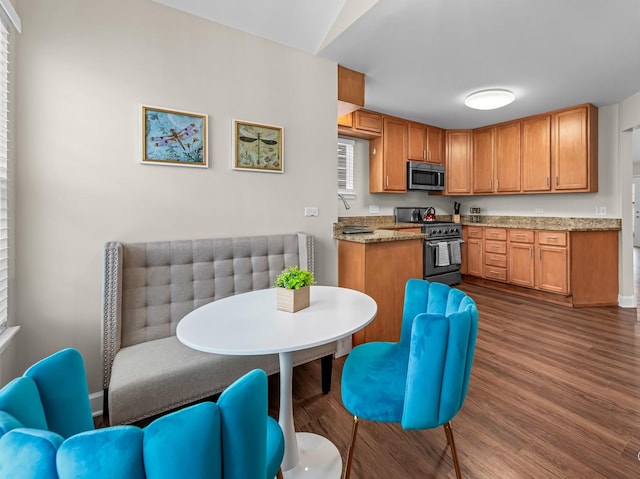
[342,279,478,479]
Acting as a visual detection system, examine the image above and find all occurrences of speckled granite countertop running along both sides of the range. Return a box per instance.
[333,215,622,243]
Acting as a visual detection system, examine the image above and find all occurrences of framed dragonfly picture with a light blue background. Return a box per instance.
[142,105,208,168]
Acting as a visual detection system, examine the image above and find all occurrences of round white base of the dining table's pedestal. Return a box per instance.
[283,432,342,479]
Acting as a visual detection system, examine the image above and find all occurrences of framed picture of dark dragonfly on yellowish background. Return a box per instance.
[232,120,284,173]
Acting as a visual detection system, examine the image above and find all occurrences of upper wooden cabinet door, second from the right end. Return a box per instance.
[522,115,551,192]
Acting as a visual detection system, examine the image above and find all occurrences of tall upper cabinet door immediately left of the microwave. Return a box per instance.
[382,118,407,191]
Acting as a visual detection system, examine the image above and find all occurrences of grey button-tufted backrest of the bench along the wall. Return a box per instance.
[103,233,314,387]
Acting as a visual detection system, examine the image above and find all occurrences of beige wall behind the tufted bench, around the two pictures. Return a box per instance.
[11,0,337,392]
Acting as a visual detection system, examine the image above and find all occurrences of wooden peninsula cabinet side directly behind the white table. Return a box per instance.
[338,239,424,346]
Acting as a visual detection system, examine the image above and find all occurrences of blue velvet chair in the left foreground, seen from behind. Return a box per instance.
[0,349,284,479]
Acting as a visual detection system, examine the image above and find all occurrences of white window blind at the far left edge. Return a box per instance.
[0,22,9,334]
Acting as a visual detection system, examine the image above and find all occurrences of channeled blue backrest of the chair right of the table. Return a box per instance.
[402,280,478,429]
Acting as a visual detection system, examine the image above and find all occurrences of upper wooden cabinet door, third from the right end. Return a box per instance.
[495,121,521,193]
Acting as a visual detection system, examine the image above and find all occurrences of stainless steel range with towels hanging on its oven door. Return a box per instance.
[395,206,462,285]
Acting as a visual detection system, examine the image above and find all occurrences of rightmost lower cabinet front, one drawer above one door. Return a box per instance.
[535,231,569,294]
